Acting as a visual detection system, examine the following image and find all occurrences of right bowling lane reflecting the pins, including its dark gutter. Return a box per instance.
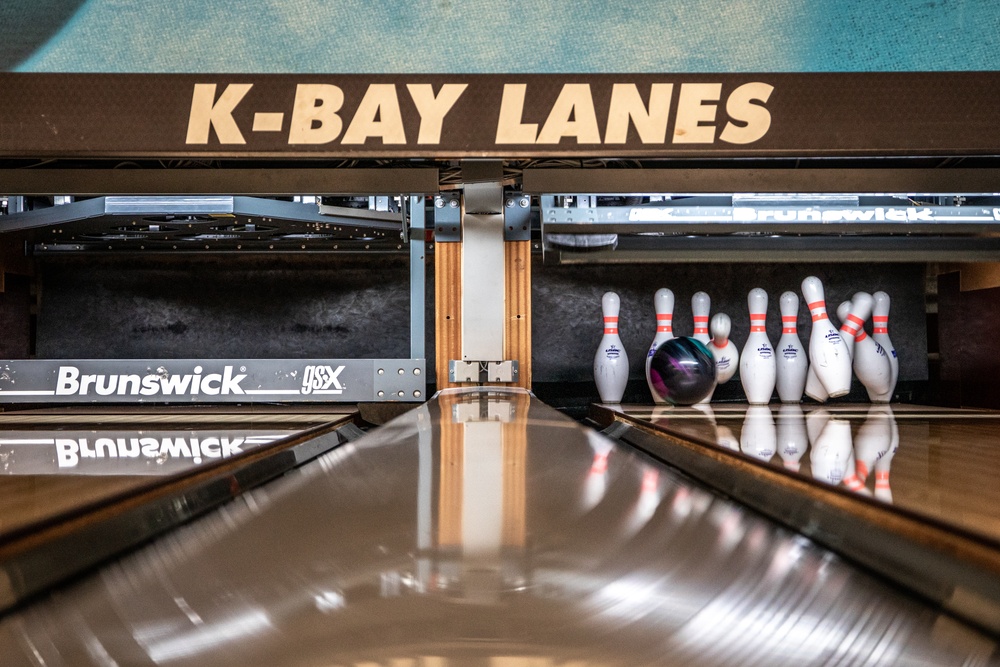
[592,404,1000,632]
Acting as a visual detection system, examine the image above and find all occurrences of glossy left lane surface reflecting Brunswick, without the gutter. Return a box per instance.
[0,406,354,540]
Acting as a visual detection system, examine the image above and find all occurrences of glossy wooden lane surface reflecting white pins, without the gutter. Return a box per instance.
[600,404,1000,544]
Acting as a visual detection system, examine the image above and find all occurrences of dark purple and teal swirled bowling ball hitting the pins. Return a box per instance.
[649,338,715,405]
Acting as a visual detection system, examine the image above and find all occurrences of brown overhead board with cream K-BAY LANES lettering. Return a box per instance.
[0,72,1000,158]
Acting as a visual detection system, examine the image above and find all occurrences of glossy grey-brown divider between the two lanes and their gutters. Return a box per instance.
[0,388,1000,667]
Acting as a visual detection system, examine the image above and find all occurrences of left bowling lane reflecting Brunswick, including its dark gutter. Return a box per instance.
[0,406,361,612]
